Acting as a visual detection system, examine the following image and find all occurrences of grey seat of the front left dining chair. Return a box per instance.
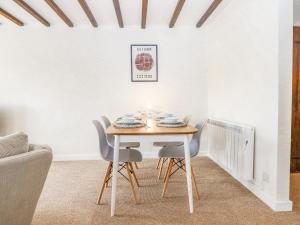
[105,149,143,162]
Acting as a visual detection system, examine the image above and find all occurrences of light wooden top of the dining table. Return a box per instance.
[107,119,198,135]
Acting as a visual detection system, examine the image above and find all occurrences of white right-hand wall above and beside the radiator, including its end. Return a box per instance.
[205,0,293,210]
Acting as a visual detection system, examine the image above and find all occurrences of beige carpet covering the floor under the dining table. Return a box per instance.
[33,158,300,225]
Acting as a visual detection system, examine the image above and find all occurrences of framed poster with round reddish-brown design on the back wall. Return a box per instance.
[131,45,158,82]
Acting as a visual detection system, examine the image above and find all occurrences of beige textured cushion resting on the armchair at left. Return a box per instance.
[0,132,29,159]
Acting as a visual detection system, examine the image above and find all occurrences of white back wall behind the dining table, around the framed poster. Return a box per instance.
[0,26,207,158]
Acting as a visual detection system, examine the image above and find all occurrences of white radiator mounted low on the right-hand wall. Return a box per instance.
[207,119,255,181]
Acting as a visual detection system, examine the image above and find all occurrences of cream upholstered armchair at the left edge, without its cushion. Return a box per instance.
[0,145,52,225]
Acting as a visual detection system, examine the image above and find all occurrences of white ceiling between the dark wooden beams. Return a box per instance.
[0,0,213,27]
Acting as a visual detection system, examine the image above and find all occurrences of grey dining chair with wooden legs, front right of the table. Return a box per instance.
[158,121,205,199]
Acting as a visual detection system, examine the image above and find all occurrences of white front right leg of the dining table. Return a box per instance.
[184,135,194,213]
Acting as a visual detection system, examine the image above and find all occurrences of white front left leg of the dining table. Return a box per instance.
[110,135,120,216]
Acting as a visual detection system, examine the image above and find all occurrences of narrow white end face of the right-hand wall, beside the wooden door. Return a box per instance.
[276,0,293,206]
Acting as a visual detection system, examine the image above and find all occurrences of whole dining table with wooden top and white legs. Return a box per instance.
[107,118,198,216]
